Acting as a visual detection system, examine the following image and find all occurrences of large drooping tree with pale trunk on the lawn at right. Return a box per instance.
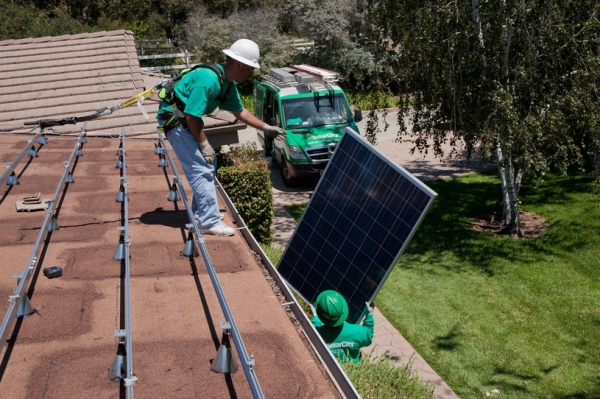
[369,0,600,235]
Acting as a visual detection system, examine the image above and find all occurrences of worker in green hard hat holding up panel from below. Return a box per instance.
[311,290,375,363]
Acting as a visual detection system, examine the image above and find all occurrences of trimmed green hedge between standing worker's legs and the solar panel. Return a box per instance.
[217,143,273,244]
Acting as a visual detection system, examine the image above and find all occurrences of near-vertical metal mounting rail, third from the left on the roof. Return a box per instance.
[115,131,138,399]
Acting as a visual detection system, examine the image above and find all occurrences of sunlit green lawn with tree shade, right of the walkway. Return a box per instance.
[280,172,600,398]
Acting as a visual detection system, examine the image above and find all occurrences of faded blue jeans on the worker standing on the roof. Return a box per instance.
[159,121,220,227]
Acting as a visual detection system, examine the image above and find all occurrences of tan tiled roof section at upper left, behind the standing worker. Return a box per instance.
[0,30,240,136]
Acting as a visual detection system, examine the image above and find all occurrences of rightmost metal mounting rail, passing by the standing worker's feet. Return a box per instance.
[157,130,265,398]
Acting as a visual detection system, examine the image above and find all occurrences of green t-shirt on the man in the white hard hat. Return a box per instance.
[157,65,244,122]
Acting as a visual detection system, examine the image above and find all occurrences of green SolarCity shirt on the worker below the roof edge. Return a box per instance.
[312,313,375,363]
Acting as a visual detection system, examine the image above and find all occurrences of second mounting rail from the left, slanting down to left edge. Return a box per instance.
[0,130,85,349]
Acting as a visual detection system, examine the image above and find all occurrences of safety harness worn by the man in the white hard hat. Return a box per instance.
[158,63,232,133]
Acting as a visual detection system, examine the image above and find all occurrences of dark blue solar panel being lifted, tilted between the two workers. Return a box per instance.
[278,128,437,323]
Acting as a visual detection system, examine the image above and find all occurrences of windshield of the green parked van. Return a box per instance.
[282,94,352,129]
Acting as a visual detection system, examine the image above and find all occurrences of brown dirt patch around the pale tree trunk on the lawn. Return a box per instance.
[471,211,550,238]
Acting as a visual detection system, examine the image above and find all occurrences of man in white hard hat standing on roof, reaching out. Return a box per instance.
[157,39,285,236]
